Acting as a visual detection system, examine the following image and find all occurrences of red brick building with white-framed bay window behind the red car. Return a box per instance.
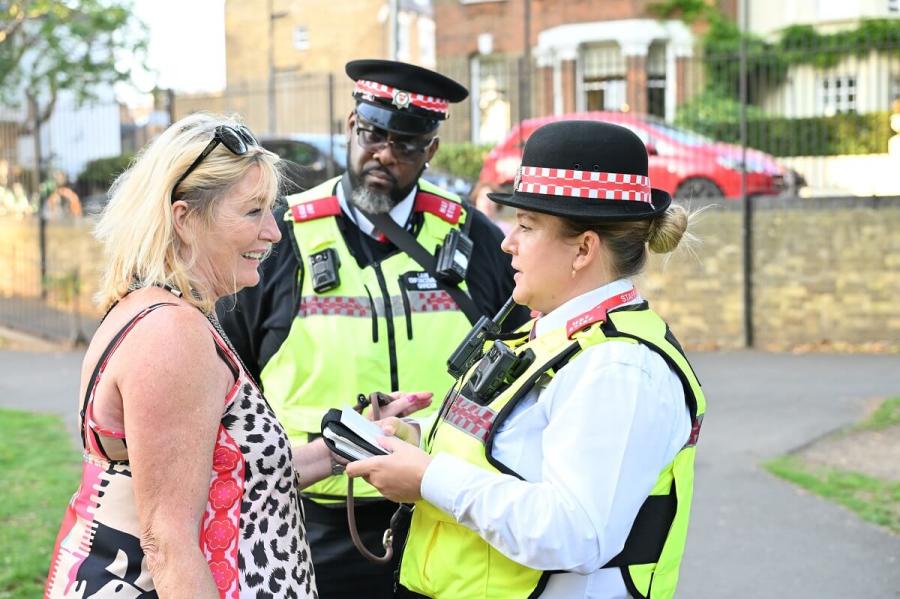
[433,0,734,142]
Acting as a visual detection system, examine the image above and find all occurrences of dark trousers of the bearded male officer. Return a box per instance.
[303,498,419,599]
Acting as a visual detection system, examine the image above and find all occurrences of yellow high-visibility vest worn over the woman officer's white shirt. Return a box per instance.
[400,303,706,599]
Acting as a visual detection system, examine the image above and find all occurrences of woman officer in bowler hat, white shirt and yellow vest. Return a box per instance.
[347,121,705,599]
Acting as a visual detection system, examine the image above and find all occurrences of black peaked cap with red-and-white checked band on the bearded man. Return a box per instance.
[344,60,469,135]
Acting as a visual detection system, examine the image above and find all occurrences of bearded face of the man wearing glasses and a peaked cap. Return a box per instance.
[347,112,438,205]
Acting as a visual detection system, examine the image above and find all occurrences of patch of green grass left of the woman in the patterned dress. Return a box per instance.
[0,409,80,599]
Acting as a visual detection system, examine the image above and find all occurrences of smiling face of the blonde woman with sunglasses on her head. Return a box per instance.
[186,165,281,297]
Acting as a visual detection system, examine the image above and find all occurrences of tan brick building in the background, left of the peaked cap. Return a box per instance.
[175,0,435,137]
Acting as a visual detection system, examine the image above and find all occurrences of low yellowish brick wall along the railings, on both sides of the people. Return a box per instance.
[0,198,900,351]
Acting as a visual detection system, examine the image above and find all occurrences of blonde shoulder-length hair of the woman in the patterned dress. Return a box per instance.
[94,113,281,314]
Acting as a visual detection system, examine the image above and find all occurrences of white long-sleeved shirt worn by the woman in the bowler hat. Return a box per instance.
[421,279,691,599]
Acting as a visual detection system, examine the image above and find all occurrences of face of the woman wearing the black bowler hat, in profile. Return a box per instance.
[500,209,585,314]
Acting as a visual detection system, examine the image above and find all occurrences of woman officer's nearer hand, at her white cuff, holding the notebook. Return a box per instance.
[347,437,431,503]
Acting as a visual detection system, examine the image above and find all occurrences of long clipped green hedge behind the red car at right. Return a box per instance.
[681,112,894,156]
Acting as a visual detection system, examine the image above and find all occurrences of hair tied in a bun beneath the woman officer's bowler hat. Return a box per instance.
[561,204,697,278]
